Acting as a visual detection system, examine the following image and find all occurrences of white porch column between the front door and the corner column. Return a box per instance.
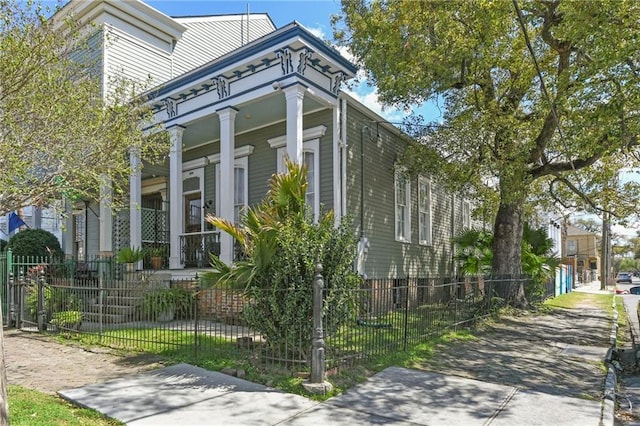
[217,107,238,265]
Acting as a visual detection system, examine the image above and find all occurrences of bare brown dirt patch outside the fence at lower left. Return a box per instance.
[4,330,163,393]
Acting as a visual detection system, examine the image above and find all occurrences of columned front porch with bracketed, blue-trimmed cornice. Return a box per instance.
[115,23,355,271]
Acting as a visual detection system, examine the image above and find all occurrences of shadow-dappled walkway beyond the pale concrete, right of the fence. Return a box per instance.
[414,307,612,399]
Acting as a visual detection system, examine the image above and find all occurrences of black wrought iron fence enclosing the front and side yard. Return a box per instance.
[3,253,536,371]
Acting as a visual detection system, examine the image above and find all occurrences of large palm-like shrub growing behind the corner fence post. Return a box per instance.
[204,161,360,355]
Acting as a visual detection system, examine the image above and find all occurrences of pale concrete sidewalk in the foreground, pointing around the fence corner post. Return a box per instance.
[59,364,613,426]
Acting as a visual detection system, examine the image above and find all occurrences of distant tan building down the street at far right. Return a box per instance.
[562,224,600,282]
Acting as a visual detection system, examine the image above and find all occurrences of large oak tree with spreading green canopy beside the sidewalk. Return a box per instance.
[335,0,640,305]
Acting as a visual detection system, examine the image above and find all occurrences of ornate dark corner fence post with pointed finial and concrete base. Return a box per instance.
[303,263,333,394]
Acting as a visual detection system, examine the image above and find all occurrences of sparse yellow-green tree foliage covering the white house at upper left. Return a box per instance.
[0,0,169,214]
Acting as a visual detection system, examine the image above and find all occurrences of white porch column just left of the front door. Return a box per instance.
[168,126,184,269]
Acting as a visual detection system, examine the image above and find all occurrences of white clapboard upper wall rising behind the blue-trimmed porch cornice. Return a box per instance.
[173,13,276,77]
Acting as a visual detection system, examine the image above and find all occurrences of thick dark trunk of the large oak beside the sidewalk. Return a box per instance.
[493,199,527,307]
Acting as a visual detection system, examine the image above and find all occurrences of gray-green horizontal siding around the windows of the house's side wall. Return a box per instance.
[347,107,452,278]
